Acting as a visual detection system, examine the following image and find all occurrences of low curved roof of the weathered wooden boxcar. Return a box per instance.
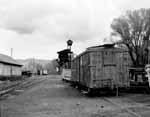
[75,44,128,59]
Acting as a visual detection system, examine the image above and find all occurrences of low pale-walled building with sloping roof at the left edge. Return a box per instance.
[0,54,22,77]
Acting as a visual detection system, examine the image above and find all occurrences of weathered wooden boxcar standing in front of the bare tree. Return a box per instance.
[71,45,130,90]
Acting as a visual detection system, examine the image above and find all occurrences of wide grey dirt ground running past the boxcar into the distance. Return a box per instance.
[0,75,150,117]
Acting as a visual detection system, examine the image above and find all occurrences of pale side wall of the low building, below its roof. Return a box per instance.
[0,63,21,76]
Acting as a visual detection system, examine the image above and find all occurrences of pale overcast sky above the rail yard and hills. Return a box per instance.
[0,0,150,59]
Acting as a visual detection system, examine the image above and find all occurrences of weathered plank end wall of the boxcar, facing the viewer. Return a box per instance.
[93,49,130,88]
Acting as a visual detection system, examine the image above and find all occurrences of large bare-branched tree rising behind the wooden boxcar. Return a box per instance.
[111,9,150,67]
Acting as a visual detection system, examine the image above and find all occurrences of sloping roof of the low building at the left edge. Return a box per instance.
[0,54,22,66]
